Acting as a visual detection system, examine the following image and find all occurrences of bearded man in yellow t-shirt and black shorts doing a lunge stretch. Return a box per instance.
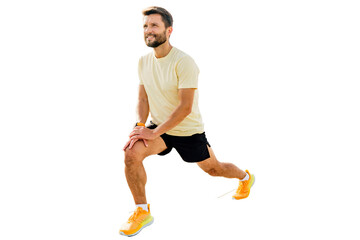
[119,7,255,236]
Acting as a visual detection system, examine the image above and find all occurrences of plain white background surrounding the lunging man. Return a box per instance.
[0,0,360,240]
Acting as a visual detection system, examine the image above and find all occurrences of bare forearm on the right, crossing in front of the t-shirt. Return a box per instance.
[154,105,191,136]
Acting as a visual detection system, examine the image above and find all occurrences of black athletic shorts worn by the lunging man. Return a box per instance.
[147,123,211,163]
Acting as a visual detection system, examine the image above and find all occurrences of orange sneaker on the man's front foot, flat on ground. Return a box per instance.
[119,204,154,237]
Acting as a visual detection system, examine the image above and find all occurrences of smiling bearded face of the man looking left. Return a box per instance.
[144,14,171,48]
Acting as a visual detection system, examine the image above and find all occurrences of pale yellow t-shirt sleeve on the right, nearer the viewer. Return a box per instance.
[176,56,200,88]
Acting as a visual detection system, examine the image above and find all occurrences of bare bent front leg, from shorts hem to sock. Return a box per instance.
[125,138,166,204]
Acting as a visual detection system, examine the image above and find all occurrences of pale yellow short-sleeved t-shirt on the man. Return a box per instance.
[139,47,204,136]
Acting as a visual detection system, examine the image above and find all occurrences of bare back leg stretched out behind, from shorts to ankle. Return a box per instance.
[198,147,246,179]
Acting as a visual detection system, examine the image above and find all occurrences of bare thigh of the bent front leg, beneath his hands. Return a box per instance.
[125,137,167,159]
